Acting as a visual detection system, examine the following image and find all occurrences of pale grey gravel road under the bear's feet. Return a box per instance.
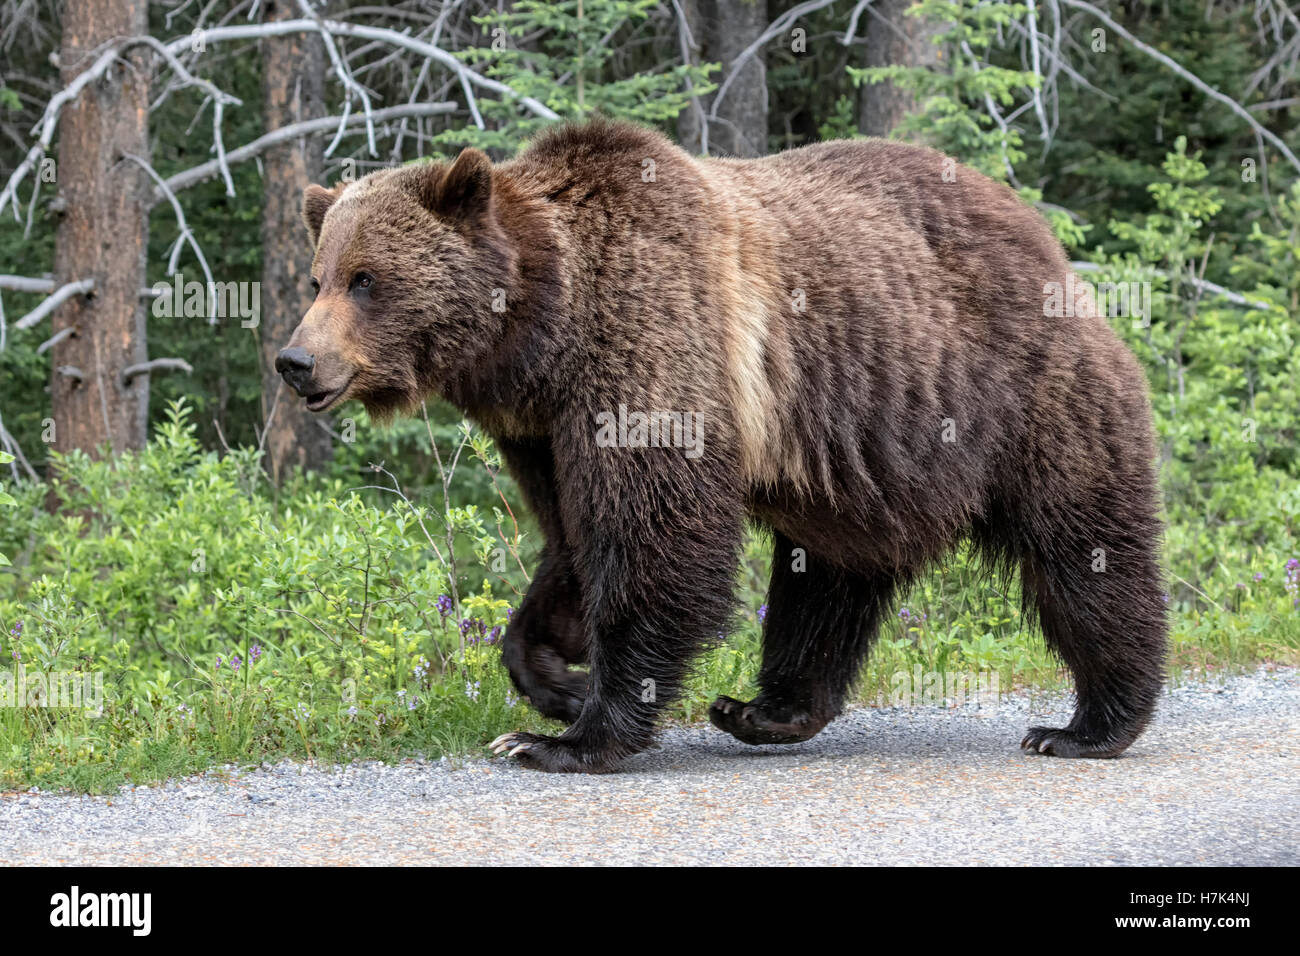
[0,669,1300,866]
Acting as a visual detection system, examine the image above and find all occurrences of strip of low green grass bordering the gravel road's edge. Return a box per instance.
[0,554,1300,792]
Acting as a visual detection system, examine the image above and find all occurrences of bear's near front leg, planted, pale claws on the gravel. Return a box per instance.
[491,424,742,773]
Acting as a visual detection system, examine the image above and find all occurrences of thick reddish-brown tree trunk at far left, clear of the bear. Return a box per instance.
[51,0,151,454]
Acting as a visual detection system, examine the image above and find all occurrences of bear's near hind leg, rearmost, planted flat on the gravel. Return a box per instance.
[1021,499,1166,757]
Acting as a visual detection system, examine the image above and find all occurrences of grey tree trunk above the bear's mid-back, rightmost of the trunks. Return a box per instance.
[858,0,939,137]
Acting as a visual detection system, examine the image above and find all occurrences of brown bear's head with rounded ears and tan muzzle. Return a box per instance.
[276,150,517,419]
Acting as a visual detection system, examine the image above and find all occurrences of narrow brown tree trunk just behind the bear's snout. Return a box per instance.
[259,0,333,484]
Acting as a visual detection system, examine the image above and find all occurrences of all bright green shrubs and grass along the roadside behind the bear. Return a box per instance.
[0,407,1300,791]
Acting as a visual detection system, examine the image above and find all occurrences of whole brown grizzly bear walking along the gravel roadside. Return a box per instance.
[276,121,1166,771]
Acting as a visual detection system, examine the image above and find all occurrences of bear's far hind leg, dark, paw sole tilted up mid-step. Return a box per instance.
[709,532,894,744]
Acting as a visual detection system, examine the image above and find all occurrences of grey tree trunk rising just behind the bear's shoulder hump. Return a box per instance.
[677,0,768,156]
